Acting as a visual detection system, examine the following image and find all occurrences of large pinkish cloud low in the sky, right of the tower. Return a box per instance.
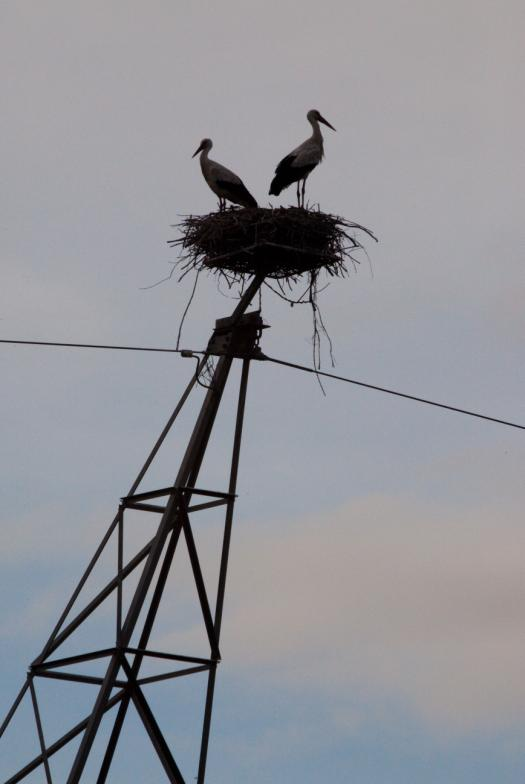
[162,486,525,735]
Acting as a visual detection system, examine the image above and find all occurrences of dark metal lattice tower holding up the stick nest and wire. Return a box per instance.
[0,276,264,784]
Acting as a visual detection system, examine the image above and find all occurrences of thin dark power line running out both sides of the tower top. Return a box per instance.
[0,339,525,430]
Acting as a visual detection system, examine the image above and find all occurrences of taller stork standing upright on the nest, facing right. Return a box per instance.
[270,109,335,207]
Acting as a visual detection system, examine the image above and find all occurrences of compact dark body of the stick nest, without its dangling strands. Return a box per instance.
[169,207,376,283]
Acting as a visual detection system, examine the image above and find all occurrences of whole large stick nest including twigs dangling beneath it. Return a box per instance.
[165,207,377,388]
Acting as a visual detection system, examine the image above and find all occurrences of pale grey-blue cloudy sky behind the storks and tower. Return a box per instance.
[0,0,525,784]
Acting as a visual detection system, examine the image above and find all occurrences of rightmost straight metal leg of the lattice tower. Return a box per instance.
[197,359,250,784]
